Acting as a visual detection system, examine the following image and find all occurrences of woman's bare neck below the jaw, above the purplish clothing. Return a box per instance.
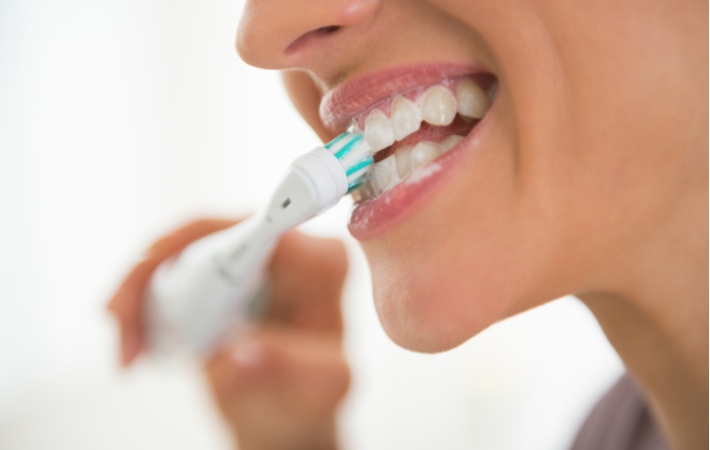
[579,187,708,450]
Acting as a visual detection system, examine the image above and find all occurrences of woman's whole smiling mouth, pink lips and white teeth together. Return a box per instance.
[321,65,498,239]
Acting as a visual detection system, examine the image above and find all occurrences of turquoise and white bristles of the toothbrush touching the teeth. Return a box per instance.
[324,131,375,192]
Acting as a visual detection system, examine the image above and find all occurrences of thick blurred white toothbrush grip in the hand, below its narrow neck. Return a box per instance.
[146,216,278,358]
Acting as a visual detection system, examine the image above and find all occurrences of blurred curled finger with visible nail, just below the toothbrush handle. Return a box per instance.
[206,327,350,416]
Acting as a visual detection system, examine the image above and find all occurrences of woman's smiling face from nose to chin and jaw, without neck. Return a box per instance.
[237,0,708,351]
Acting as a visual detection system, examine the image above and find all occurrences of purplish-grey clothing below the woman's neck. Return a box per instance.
[572,374,670,450]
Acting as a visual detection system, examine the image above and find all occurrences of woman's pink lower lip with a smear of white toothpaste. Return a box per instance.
[348,102,498,241]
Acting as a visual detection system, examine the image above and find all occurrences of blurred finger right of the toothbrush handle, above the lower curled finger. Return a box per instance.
[269,232,348,331]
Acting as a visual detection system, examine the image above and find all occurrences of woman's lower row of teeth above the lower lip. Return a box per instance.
[352,134,464,202]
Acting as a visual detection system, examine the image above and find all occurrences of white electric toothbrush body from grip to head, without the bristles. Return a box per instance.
[146,147,348,356]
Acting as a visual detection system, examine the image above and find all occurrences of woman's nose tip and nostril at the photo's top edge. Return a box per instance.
[236,0,383,69]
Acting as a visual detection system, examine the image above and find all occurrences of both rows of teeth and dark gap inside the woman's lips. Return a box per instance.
[351,74,498,203]
